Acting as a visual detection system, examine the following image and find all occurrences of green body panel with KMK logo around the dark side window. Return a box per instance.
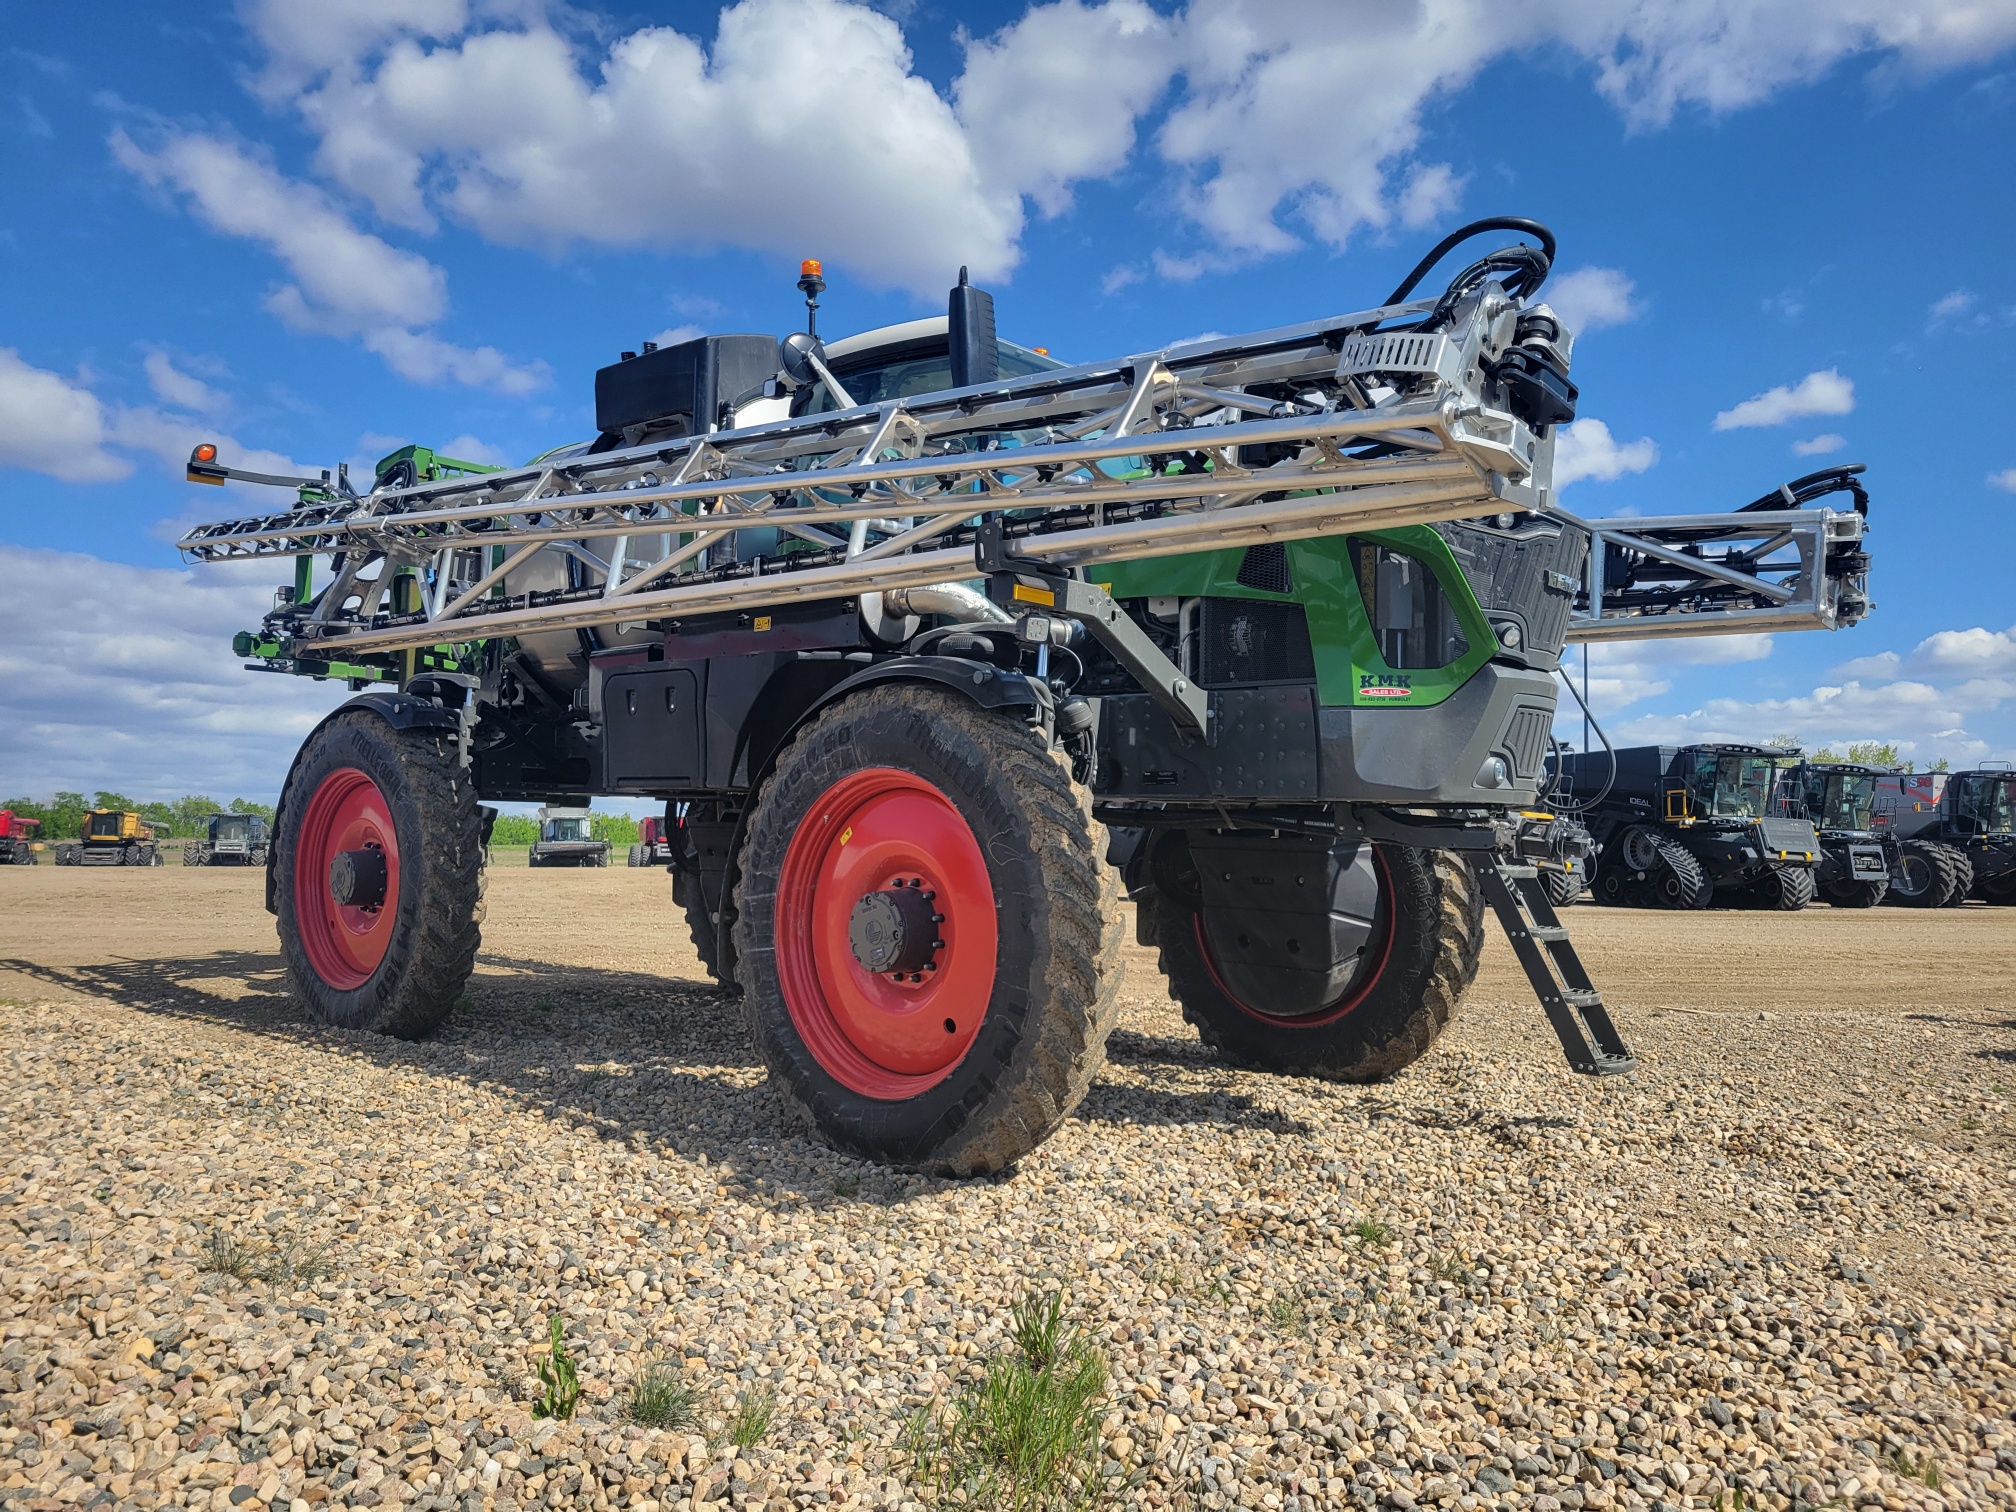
[1085,524,1498,708]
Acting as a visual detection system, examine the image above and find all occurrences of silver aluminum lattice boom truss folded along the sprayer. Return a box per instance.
[179,282,1859,657]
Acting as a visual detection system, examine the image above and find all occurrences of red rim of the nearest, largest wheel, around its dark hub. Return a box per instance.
[776,766,998,1103]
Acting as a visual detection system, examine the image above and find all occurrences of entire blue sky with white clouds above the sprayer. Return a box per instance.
[0,0,2016,796]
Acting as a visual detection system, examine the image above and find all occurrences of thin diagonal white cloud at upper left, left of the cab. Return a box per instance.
[111,129,548,393]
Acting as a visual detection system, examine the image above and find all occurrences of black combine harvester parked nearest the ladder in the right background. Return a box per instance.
[1554,746,1820,909]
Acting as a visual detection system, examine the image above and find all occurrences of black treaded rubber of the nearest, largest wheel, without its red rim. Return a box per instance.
[737,683,1123,1175]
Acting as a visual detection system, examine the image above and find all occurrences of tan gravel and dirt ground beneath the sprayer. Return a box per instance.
[0,869,2016,1512]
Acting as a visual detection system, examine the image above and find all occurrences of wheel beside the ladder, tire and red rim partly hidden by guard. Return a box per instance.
[1155,837,1484,1083]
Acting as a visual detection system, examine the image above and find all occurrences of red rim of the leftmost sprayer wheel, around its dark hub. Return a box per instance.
[294,766,399,992]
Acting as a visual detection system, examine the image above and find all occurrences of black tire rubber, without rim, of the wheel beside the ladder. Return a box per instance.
[1155,847,1484,1083]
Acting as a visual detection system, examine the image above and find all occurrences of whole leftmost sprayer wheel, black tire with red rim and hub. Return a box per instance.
[272,710,484,1040]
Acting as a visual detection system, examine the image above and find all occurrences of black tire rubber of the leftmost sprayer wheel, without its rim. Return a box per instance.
[274,710,486,1040]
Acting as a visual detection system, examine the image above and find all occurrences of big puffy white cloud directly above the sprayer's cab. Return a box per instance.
[302,0,1024,290]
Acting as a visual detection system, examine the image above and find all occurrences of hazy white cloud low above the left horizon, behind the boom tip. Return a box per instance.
[0,544,349,800]
